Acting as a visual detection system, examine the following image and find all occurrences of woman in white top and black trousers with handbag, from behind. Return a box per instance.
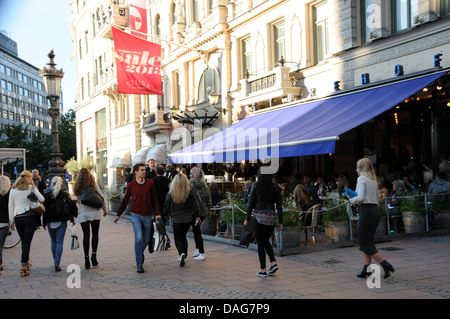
[8,171,45,277]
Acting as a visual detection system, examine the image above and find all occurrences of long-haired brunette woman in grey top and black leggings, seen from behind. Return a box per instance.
[73,167,108,269]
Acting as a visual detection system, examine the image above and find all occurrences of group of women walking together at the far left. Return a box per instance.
[0,168,107,277]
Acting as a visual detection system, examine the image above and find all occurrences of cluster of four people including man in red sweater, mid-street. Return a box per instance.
[114,160,212,273]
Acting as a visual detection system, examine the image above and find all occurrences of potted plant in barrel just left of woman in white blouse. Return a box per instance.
[323,198,350,242]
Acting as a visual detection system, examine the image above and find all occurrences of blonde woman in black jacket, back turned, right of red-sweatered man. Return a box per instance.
[165,173,200,267]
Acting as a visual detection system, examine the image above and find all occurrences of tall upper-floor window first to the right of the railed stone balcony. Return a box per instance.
[314,1,329,63]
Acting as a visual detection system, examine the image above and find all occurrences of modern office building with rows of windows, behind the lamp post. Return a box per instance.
[0,32,55,138]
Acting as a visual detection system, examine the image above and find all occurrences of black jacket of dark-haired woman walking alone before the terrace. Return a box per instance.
[246,182,283,224]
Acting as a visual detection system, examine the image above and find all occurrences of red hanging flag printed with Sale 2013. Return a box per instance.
[111,27,163,95]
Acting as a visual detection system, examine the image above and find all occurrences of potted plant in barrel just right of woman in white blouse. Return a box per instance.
[400,194,426,233]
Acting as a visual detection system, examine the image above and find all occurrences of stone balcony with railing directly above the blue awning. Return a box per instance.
[236,66,302,109]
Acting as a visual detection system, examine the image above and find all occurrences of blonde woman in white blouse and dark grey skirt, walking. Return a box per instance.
[347,158,395,278]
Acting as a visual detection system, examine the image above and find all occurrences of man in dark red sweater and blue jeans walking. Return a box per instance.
[114,163,161,273]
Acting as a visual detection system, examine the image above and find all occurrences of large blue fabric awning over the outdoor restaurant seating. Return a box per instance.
[169,71,447,164]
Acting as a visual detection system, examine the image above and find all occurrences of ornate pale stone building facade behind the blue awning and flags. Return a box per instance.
[71,0,450,192]
